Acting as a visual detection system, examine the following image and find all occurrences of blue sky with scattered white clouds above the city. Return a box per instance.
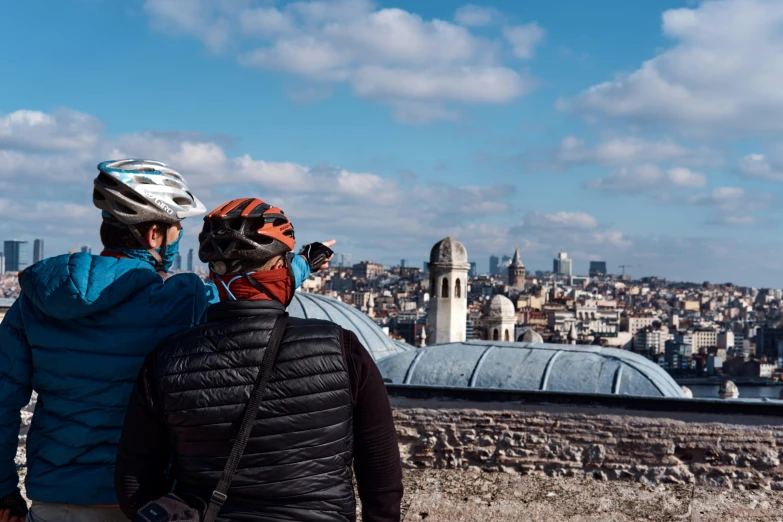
[0,0,783,288]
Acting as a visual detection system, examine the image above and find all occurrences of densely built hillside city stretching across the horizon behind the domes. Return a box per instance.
[6,234,783,396]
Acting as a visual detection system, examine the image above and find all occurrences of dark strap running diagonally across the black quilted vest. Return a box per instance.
[204,313,288,522]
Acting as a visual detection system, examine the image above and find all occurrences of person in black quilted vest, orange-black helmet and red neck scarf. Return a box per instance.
[115,198,403,522]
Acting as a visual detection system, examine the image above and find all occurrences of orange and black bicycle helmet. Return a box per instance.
[198,198,295,275]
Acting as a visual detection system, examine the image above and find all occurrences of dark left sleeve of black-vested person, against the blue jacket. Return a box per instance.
[114,354,170,520]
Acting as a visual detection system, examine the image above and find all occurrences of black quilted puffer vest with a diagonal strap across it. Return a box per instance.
[138,301,356,522]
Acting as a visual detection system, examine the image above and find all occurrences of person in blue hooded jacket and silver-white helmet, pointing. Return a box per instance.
[0,160,333,522]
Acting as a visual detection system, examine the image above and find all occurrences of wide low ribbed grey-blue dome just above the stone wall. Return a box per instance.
[378,341,684,397]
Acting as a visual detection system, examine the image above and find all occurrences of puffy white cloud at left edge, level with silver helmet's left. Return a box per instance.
[0,109,103,152]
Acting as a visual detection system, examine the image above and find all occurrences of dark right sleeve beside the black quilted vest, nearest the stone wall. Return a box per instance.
[343,330,403,522]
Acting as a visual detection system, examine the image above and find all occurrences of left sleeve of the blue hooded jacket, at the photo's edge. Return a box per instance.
[0,297,33,498]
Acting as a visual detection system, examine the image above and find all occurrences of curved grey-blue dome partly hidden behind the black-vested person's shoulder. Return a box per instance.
[288,291,405,361]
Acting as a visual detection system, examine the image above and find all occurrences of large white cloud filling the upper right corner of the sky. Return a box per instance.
[559,0,783,134]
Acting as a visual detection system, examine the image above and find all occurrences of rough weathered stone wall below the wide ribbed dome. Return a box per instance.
[392,398,783,490]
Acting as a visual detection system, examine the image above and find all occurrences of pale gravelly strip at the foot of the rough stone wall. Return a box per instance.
[396,470,783,522]
